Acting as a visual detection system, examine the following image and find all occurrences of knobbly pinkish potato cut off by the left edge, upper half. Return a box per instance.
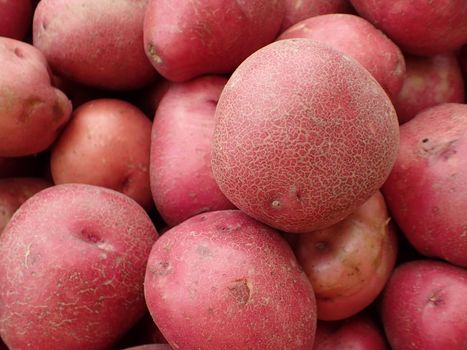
[0,37,71,157]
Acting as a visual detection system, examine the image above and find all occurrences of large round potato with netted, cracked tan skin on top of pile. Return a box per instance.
[212,39,399,232]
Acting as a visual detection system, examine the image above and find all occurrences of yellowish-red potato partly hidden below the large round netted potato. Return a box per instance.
[295,191,397,320]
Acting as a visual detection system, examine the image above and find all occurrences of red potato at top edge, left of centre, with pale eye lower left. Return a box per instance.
[144,0,285,82]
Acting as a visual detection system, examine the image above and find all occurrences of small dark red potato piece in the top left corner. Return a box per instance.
[0,0,32,40]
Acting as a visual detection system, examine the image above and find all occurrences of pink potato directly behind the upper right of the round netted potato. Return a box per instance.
[279,14,405,100]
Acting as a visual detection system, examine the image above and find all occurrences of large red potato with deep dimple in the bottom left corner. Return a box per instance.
[0,184,157,350]
